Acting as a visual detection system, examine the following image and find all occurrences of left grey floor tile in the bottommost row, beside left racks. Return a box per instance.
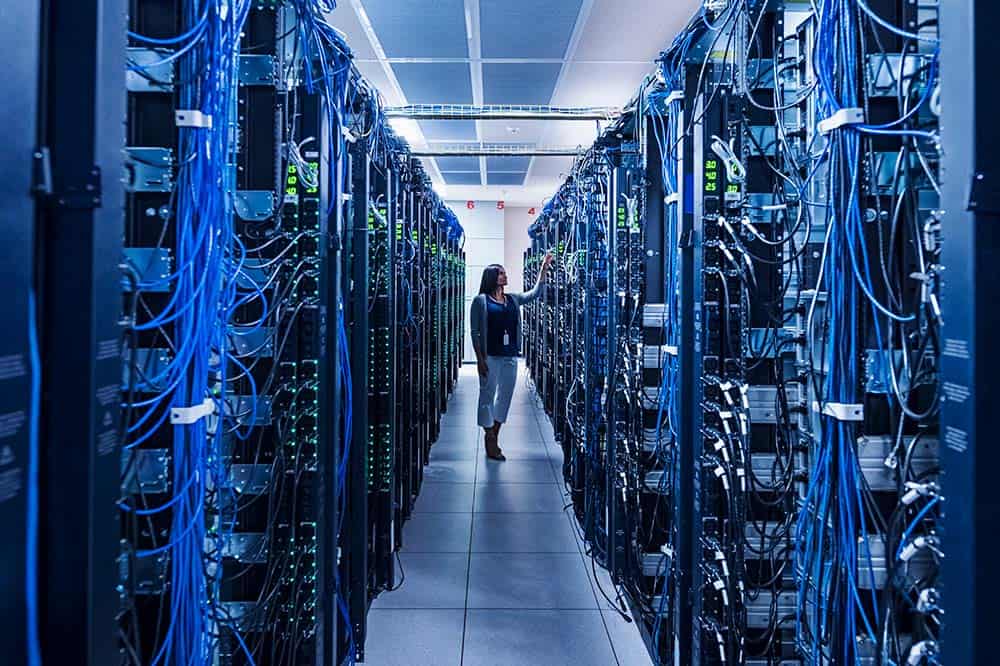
[365,609,465,666]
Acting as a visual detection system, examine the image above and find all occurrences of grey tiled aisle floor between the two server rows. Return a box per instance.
[365,366,650,666]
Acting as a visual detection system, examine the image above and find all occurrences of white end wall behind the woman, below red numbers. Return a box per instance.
[448,201,541,361]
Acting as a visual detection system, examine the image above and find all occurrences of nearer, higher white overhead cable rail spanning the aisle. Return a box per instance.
[385,104,621,121]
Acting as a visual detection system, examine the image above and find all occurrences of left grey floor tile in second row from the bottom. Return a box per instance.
[372,551,472,609]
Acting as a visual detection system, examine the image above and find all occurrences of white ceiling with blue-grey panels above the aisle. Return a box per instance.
[329,0,701,206]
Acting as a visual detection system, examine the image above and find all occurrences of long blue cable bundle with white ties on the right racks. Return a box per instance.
[795,0,937,663]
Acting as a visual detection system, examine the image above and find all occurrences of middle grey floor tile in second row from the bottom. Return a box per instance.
[469,553,598,610]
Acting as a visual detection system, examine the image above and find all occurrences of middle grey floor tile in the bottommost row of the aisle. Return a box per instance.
[462,610,616,666]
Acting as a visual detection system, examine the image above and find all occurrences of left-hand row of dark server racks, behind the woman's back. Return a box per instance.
[0,0,465,666]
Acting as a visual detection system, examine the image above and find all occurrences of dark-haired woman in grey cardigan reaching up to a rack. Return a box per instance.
[469,253,552,460]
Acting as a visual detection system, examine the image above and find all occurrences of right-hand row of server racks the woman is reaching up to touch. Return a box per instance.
[524,0,995,666]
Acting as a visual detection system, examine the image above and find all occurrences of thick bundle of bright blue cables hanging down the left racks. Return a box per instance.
[122,0,256,666]
